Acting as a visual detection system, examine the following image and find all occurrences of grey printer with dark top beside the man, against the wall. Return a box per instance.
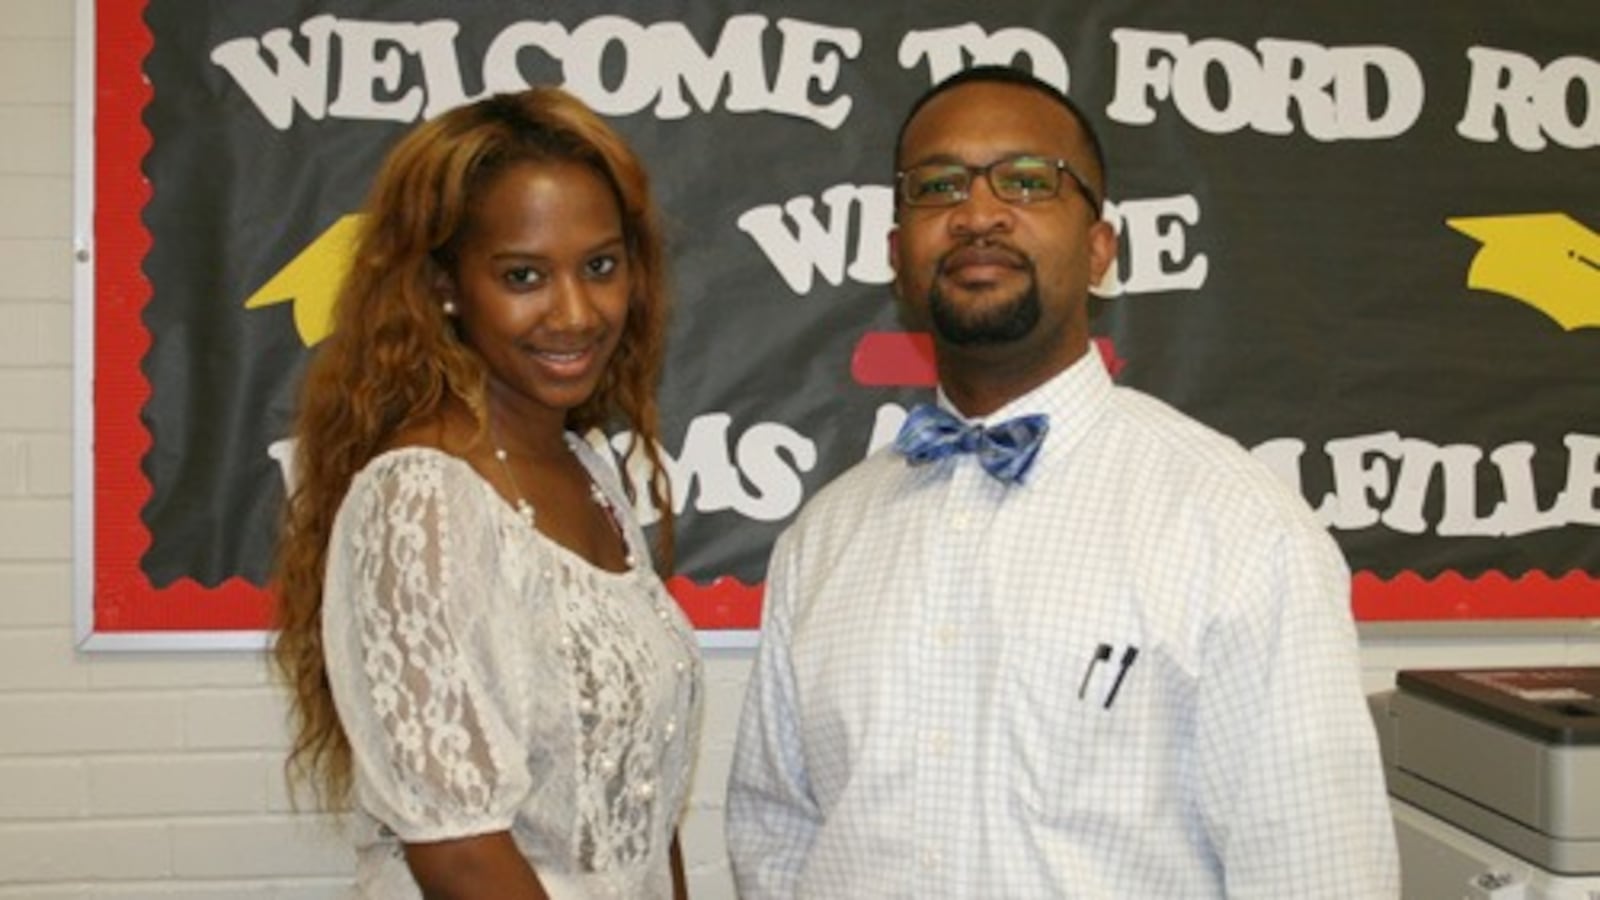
[1370,666,1600,900]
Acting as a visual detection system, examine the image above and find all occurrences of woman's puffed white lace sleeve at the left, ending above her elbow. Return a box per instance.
[323,450,531,841]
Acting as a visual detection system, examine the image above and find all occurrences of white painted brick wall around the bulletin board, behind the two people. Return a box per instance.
[0,0,1600,900]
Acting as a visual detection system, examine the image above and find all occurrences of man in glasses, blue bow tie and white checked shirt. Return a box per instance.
[728,67,1398,900]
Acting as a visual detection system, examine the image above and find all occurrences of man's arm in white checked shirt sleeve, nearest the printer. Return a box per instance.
[1195,528,1398,900]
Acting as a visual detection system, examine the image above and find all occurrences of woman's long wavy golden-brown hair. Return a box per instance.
[274,88,672,809]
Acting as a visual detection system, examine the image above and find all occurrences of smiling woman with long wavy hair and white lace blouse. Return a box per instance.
[275,88,701,898]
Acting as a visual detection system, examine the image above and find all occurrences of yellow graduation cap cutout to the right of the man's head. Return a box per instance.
[1445,213,1600,331]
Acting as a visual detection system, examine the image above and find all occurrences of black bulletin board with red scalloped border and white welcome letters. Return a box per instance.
[77,0,1600,649]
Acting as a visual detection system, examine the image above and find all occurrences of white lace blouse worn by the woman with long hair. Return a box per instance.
[323,437,701,900]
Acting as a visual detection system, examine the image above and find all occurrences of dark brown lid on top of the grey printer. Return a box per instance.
[1395,666,1600,745]
